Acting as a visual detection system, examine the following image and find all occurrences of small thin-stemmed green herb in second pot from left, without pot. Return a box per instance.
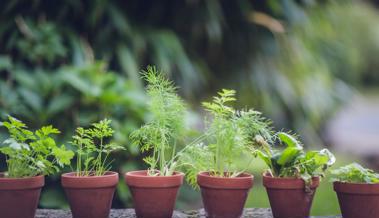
[71,119,123,176]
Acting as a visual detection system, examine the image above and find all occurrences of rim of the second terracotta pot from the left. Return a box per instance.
[61,171,118,189]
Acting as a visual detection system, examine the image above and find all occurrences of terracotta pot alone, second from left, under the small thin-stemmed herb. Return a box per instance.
[62,172,118,218]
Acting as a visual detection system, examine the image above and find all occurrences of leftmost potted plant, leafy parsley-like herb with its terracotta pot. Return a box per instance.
[0,116,74,218]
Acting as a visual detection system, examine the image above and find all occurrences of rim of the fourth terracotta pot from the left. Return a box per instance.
[197,171,254,189]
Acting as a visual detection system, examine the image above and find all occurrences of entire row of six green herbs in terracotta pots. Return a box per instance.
[0,67,379,218]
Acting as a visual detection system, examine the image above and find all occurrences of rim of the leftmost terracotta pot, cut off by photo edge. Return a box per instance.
[0,172,45,190]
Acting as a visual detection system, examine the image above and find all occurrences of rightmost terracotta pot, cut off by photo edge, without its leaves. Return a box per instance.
[333,182,379,218]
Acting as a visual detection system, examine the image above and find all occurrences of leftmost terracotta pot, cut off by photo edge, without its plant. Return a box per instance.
[0,173,45,218]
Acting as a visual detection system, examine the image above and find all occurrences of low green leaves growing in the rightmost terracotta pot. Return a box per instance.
[331,163,379,184]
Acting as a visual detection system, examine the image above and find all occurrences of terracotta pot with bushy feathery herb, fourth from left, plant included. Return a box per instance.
[180,89,272,218]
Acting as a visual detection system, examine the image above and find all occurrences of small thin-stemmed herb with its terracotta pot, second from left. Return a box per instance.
[61,119,123,218]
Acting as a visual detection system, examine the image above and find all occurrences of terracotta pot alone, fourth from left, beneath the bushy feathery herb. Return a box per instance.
[197,172,254,218]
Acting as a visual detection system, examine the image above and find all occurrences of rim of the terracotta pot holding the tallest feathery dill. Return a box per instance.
[124,170,184,188]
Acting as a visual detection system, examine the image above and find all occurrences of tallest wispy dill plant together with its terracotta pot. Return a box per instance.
[125,67,186,218]
